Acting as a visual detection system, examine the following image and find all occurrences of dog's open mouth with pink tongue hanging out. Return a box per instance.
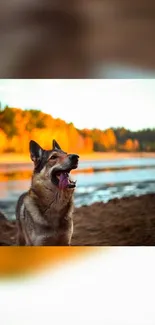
[52,170,76,189]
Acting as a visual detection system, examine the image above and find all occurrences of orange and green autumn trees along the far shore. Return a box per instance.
[0,106,155,153]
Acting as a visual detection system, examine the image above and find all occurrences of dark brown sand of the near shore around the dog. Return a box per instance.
[0,194,155,246]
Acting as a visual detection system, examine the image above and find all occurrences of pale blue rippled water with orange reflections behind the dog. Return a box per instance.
[0,158,155,217]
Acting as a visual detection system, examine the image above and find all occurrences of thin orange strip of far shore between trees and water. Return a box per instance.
[0,152,155,165]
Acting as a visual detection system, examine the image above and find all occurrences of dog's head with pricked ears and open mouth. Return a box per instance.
[30,140,79,190]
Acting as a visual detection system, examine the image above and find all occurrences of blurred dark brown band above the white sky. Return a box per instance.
[0,0,155,78]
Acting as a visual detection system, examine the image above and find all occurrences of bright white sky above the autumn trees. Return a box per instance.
[0,79,155,130]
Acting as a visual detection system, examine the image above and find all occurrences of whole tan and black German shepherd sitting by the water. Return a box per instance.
[16,140,79,246]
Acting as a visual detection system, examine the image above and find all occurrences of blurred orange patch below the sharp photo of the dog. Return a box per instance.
[0,247,93,278]
